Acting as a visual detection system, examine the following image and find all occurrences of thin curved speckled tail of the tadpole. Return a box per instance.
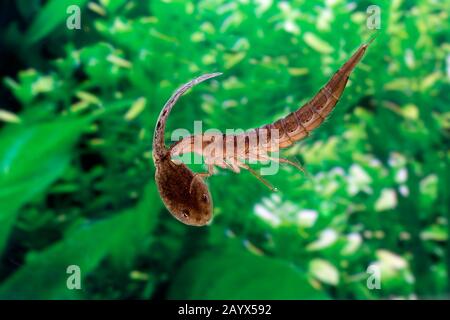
[153,72,222,160]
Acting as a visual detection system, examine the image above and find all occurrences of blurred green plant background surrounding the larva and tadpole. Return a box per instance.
[0,0,450,299]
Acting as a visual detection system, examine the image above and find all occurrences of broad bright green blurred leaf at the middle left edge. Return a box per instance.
[0,118,87,253]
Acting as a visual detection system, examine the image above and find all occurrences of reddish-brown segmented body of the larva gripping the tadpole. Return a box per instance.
[168,38,369,163]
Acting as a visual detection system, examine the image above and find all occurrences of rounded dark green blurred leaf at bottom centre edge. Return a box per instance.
[169,251,327,299]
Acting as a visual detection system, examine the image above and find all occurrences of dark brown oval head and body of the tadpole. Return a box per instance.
[155,159,213,226]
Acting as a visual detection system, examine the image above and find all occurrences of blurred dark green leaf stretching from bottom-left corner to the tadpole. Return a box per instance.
[0,183,158,299]
